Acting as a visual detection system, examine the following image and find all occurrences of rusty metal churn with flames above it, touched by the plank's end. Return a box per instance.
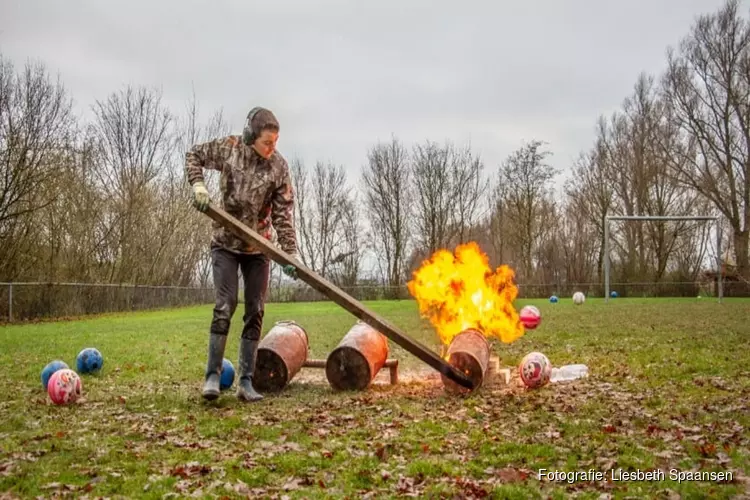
[441,328,490,394]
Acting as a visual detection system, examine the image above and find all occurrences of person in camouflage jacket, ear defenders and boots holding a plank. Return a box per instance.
[185,108,297,401]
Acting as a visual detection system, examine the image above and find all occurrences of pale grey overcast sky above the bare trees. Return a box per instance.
[0,0,750,189]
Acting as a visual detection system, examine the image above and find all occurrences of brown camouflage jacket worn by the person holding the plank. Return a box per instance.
[185,135,297,254]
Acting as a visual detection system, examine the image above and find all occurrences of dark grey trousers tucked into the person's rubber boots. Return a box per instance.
[211,247,271,340]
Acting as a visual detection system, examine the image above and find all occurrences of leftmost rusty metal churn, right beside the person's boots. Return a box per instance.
[253,321,309,392]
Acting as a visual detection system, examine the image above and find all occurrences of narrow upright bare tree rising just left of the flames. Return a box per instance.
[362,137,411,286]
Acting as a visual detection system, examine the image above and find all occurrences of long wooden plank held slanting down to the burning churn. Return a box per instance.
[206,203,474,390]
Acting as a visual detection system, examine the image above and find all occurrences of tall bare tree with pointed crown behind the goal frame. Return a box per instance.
[597,74,708,281]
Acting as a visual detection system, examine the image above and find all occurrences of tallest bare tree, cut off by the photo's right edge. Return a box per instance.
[663,0,750,276]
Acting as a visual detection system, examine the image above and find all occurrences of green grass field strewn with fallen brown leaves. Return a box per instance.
[0,299,750,498]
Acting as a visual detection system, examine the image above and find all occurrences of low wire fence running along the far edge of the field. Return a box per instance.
[0,281,750,323]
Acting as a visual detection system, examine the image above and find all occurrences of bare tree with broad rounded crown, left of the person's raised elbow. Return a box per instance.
[93,87,175,283]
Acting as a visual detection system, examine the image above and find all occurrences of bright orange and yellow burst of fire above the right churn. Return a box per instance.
[408,242,524,345]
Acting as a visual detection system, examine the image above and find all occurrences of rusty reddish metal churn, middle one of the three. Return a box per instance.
[326,321,388,390]
